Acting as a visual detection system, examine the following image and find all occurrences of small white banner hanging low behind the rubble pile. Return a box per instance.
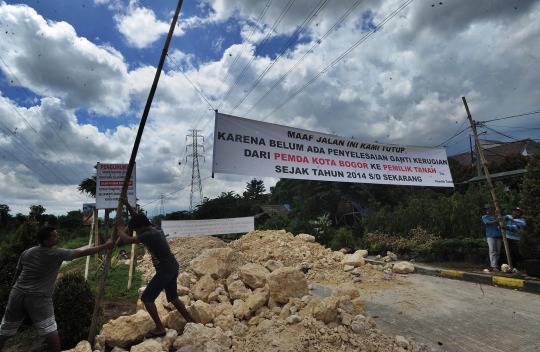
[161,216,255,238]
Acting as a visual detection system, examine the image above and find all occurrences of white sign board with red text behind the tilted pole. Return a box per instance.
[96,163,137,209]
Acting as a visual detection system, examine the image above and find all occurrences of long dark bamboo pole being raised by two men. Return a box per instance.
[88,0,183,345]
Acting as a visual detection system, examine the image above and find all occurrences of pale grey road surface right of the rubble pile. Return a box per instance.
[364,274,540,352]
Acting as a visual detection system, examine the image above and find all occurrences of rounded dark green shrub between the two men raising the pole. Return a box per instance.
[53,273,95,349]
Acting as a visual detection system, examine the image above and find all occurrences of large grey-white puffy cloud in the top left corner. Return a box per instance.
[0,3,129,116]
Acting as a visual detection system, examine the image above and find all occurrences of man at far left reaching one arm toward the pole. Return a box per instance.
[0,226,115,352]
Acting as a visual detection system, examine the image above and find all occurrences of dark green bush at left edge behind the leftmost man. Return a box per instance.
[0,221,38,316]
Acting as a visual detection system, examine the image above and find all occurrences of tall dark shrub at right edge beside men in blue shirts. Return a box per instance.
[520,153,540,259]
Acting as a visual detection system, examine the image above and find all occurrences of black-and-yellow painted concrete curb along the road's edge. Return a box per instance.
[364,258,540,294]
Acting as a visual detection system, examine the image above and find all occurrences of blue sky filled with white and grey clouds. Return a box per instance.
[0,0,540,215]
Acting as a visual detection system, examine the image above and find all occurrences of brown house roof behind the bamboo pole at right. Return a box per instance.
[448,139,540,165]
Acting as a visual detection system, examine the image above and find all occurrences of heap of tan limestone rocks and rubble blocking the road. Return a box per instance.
[64,230,425,352]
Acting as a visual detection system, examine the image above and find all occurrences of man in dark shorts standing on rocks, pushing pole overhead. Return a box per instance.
[114,205,193,338]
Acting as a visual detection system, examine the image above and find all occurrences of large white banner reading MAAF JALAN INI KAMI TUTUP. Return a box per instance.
[212,113,454,187]
